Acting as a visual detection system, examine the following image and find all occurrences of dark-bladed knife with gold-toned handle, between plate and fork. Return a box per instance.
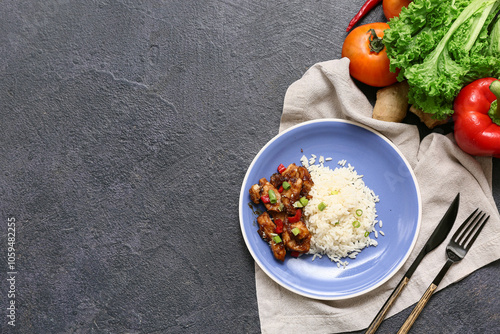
[365,193,460,334]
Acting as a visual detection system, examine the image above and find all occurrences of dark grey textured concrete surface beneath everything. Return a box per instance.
[0,0,500,333]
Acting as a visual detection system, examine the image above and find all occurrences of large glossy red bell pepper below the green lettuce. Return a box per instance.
[453,78,500,158]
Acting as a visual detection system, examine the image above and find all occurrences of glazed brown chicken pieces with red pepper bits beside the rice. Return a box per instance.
[249,163,314,261]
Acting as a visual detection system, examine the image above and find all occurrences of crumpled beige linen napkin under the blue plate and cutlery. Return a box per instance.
[255,58,500,334]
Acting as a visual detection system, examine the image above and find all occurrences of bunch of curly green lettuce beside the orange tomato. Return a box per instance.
[384,0,500,119]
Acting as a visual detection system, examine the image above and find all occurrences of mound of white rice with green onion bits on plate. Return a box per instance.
[304,159,379,268]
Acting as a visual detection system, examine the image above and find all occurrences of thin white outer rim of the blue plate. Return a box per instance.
[238,118,422,300]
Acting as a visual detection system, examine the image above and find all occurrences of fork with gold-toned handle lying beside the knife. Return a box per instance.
[397,209,490,334]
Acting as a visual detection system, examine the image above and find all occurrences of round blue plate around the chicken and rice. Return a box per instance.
[239,119,422,300]
